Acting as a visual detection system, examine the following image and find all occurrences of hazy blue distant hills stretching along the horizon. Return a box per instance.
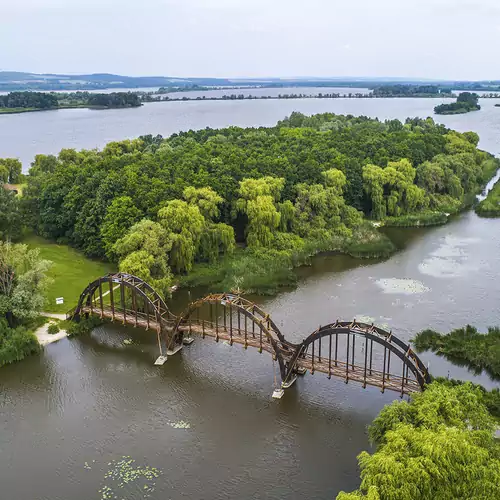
[0,71,500,91]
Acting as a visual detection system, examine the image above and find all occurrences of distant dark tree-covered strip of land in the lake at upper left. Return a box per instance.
[0,91,142,114]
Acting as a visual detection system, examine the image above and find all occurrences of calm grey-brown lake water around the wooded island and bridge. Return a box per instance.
[0,95,500,500]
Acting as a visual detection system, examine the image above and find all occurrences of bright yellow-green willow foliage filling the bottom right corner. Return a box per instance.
[337,383,500,500]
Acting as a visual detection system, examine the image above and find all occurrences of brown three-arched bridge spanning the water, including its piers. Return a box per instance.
[68,273,430,397]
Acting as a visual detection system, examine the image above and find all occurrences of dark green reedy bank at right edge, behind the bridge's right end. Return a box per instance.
[414,325,500,378]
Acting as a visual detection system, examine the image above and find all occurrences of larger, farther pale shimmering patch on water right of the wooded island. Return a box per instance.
[418,235,481,278]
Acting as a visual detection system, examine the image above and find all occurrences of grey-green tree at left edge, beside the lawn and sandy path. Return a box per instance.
[0,241,51,328]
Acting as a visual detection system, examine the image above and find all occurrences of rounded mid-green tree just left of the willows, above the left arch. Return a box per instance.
[101,196,143,260]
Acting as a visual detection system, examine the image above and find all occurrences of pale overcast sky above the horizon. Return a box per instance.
[0,0,500,80]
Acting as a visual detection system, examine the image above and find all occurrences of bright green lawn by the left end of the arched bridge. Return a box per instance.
[23,235,116,313]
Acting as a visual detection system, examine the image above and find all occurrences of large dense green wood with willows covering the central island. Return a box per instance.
[19,113,491,290]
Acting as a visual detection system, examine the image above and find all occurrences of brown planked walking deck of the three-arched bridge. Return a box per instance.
[82,306,421,394]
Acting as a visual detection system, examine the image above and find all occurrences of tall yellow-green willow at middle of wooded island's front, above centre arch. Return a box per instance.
[236,177,285,248]
